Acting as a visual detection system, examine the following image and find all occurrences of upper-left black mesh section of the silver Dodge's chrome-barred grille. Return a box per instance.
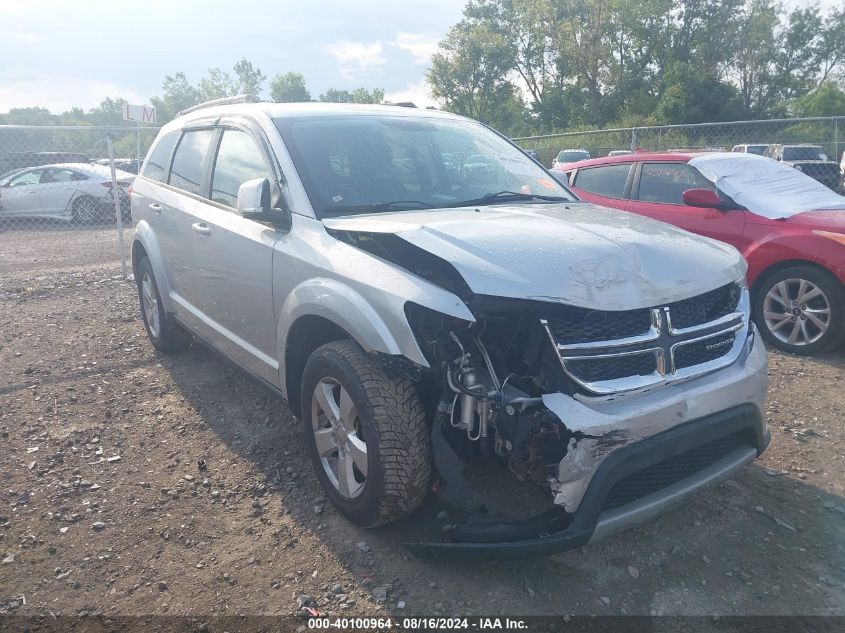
[546,306,651,345]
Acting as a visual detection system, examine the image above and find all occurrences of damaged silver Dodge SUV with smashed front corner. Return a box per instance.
[132,98,769,556]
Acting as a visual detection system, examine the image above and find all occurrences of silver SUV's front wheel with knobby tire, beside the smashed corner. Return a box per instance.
[301,341,431,527]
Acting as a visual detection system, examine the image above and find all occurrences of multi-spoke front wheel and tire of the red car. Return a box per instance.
[752,265,845,354]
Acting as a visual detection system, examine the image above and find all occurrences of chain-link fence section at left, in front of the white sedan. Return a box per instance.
[0,125,158,291]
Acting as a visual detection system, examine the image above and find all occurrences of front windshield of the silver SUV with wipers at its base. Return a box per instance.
[275,115,577,218]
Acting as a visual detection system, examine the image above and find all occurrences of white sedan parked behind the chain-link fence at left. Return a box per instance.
[0,163,135,224]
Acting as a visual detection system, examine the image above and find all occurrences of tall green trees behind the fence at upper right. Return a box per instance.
[427,0,845,134]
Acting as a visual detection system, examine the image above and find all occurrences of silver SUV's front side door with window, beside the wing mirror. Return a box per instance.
[181,121,279,385]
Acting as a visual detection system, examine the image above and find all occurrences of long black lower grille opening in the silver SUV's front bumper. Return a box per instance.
[602,431,751,510]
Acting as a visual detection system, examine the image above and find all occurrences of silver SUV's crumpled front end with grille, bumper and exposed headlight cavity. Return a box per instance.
[409,282,768,557]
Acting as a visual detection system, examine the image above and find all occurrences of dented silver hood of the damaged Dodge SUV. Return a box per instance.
[323,202,746,310]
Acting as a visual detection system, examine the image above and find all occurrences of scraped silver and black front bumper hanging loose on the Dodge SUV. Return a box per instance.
[407,335,769,559]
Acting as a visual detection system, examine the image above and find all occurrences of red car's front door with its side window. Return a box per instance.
[626,162,745,248]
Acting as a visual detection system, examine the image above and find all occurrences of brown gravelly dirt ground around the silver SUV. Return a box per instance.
[0,227,845,615]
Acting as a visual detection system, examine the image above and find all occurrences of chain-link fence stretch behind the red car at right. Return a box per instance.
[514,116,845,192]
